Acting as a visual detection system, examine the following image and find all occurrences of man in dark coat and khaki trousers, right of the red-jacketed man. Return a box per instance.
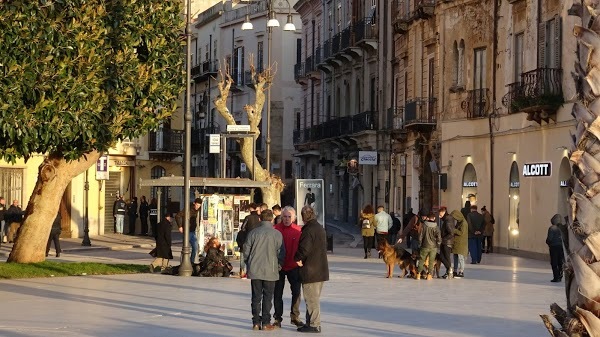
[294,206,329,332]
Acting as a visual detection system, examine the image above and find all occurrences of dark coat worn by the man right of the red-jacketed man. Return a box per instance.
[294,219,329,283]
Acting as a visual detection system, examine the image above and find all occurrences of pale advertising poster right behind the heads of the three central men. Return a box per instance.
[296,179,325,226]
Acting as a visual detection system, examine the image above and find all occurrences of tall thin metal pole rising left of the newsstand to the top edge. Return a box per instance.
[178,0,192,276]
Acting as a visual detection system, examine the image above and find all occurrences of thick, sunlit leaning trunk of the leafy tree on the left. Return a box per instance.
[8,152,100,263]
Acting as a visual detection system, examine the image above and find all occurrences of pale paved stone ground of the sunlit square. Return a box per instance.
[0,232,565,337]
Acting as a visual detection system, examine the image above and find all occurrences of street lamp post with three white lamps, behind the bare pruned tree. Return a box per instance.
[242,0,296,174]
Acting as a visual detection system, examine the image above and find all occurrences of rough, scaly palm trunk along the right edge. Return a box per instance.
[542,1,600,336]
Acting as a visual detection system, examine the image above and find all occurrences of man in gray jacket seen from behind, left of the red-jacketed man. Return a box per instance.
[244,209,285,330]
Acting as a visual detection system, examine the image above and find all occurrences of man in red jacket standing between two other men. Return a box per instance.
[273,206,304,327]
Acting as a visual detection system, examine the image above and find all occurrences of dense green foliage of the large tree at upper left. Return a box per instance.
[0,0,184,162]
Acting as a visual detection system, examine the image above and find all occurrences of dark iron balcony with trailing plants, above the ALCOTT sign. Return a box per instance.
[502,68,564,123]
